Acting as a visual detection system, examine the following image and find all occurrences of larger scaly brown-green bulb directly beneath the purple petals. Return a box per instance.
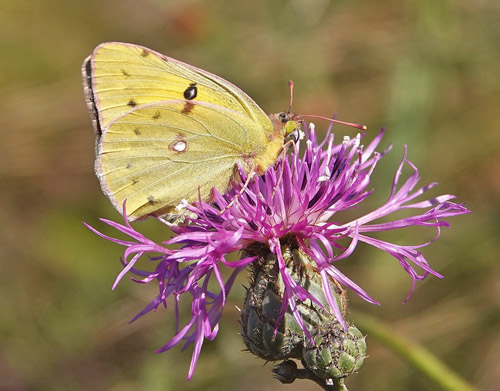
[241,240,346,361]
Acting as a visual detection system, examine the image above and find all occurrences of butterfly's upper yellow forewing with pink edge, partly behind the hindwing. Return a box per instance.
[83,42,273,133]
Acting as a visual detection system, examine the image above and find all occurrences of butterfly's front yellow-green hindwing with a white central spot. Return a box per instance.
[96,100,272,220]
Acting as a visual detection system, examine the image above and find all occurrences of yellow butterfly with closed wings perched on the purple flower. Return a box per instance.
[82,42,298,220]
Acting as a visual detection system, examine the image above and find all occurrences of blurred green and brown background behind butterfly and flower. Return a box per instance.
[0,0,500,391]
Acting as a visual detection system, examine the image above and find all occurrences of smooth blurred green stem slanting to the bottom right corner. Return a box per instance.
[354,314,477,391]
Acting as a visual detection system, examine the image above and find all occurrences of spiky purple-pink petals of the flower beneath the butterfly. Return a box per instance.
[85,124,468,378]
